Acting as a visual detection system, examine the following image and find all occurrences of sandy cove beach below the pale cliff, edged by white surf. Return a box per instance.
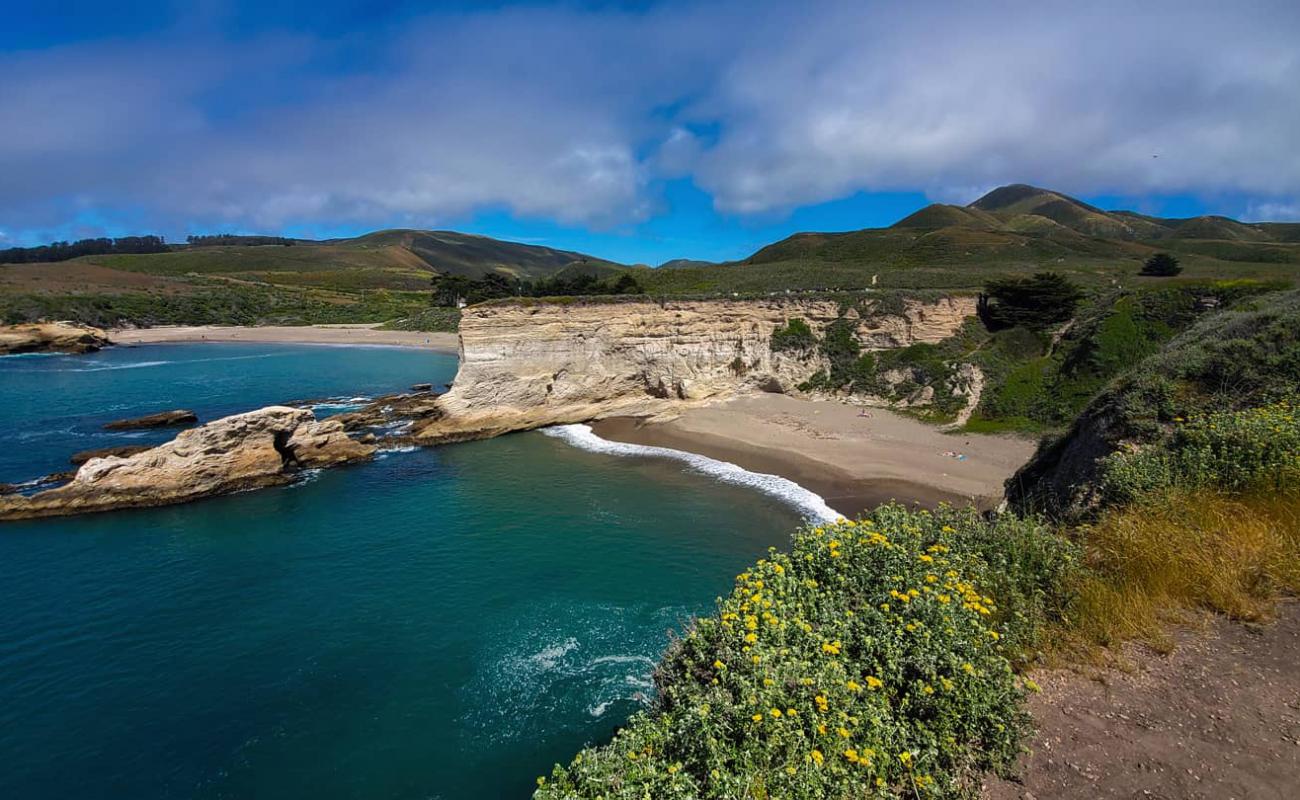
[593,394,1035,515]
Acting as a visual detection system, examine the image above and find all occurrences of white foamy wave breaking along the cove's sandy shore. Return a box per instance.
[542,425,842,522]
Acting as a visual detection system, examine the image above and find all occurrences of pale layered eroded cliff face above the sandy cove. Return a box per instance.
[416,297,975,441]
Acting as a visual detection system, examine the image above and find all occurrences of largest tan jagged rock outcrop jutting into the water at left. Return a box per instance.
[0,406,374,519]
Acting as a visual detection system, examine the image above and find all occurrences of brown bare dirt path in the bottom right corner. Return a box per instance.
[984,602,1300,800]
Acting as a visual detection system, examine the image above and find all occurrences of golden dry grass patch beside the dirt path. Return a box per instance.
[1053,490,1300,660]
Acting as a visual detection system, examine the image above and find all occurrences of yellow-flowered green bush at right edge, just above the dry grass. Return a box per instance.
[1102,401,1300,502]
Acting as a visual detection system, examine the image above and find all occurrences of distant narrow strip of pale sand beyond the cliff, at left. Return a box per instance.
[108,325,458,353]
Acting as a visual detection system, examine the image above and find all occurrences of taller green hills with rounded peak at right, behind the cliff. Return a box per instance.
[644,183,1300,294]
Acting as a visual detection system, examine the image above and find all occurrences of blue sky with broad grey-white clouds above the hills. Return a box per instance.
[0,0,1300,264]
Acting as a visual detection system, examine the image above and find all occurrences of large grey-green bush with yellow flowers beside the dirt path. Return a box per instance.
[536,505,1050,800]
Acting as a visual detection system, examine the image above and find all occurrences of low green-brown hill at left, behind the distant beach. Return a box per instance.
[0,230,625,329]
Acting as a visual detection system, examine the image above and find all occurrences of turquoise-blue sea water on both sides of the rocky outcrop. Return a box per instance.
[0,345,798,799]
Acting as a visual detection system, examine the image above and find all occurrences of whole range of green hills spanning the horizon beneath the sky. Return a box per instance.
[0,183,1300,327]
